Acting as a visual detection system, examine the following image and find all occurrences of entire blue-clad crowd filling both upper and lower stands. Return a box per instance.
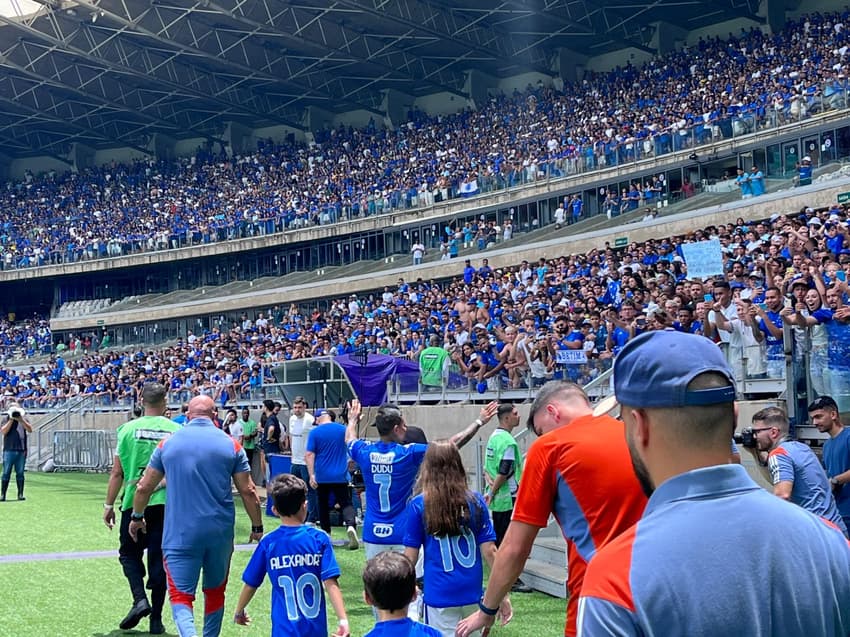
[0,7,850,418]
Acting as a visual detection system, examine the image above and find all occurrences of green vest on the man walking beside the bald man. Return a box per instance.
[115,416,180,511]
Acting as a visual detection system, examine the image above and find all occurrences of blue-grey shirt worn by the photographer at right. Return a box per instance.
[767,440,847,535]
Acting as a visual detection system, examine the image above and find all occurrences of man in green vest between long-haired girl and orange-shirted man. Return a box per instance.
[484,403,531,593]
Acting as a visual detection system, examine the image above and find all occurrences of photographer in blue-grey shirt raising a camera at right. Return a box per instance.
[741,407,847,536]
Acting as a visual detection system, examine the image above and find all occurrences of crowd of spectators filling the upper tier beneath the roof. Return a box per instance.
[0,12,850,269]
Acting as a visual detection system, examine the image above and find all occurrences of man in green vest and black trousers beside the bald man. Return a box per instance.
[103,383,180,635]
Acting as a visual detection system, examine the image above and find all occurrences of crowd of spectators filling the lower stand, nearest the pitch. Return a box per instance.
[0,199,850,408]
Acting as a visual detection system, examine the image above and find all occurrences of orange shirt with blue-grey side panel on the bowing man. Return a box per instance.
[512,415,646,636]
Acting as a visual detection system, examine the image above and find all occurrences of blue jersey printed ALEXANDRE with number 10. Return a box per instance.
[242,526,339,637]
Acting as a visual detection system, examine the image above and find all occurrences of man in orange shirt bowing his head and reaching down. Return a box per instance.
[457,381,646,637]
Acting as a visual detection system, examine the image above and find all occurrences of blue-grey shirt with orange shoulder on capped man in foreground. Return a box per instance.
[578,464,850,637]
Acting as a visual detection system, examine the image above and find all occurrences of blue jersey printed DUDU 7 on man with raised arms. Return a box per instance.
[348,440,428,544]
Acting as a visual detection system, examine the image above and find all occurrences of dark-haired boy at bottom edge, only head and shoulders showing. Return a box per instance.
[363,551,440,637]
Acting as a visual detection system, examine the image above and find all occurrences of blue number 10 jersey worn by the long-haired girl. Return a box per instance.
[404,493,496,608]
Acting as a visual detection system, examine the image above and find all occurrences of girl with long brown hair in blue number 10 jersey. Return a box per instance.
[404,440,513,637]
